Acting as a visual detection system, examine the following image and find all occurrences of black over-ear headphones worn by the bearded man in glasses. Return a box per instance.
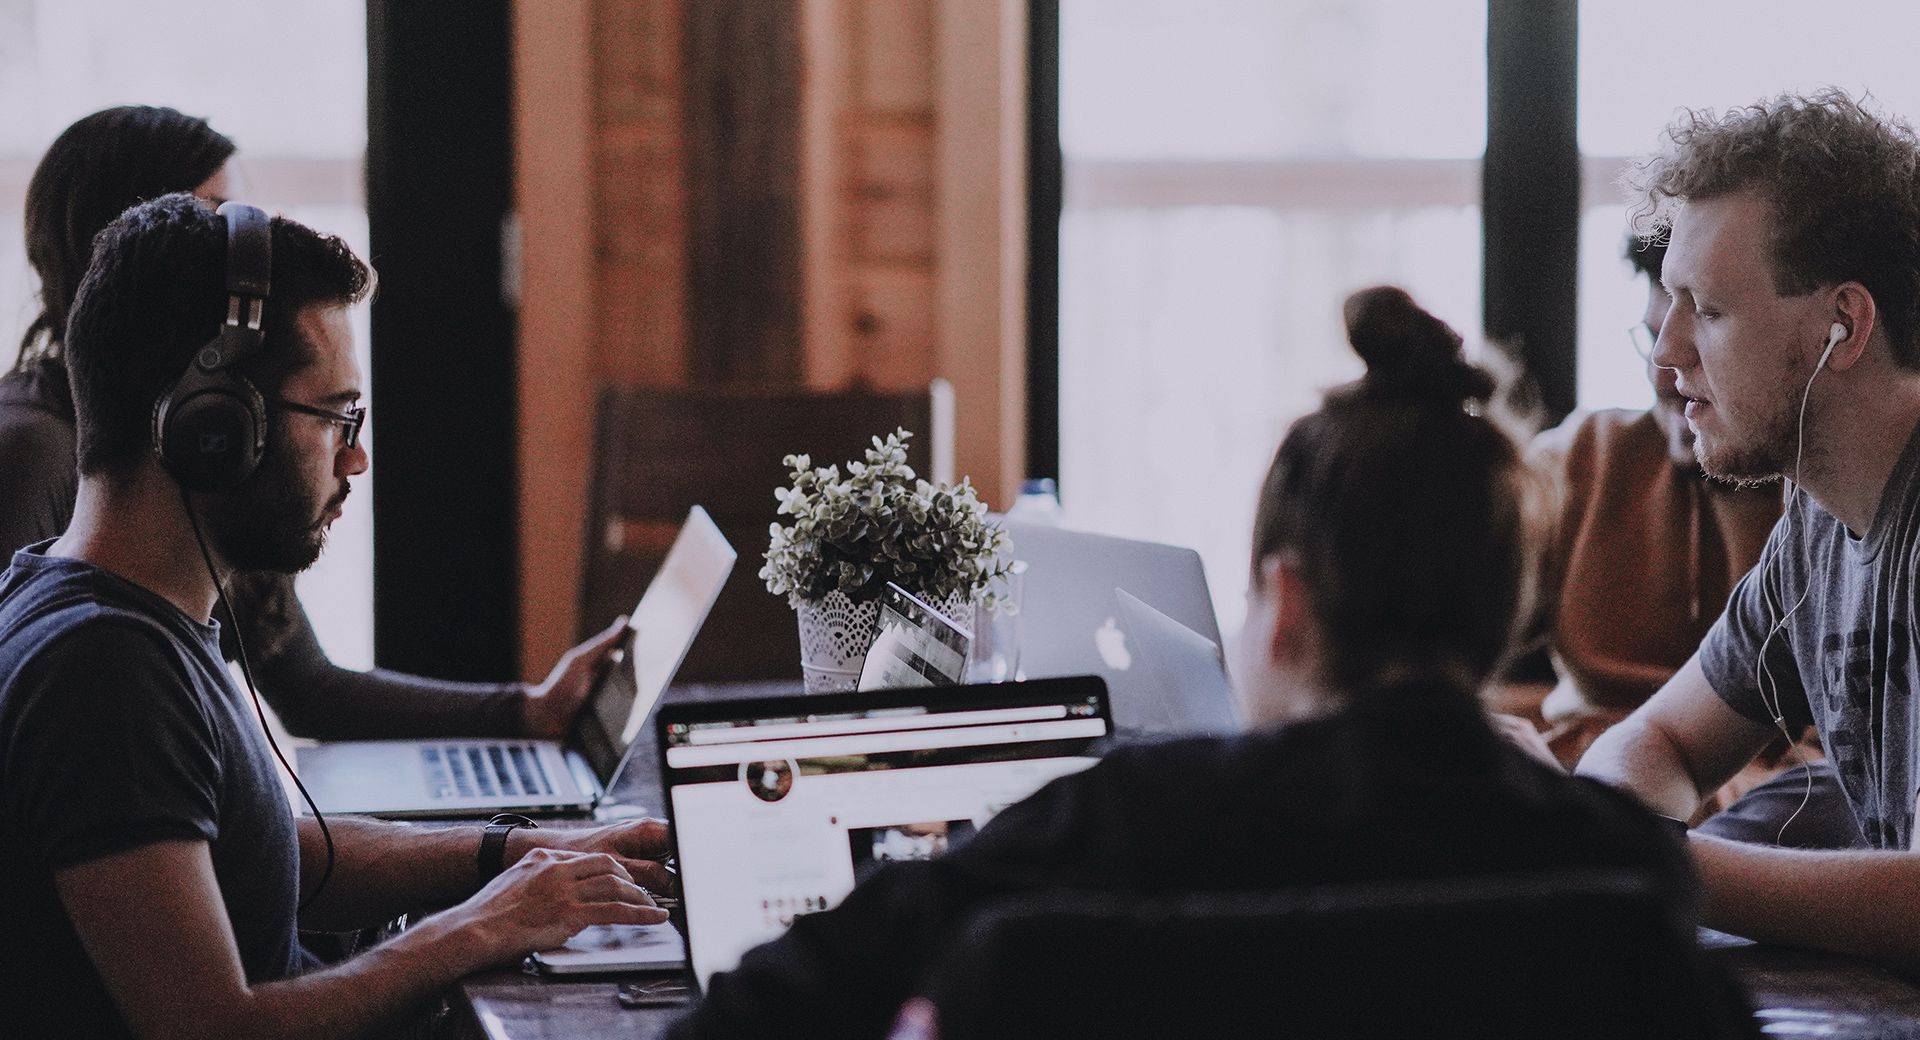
[154,201,273,491]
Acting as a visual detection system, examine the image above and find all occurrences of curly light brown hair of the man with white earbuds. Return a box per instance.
[1628,88,1920,368]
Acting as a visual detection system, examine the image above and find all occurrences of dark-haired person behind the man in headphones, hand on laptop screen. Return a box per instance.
[0,106,626,741]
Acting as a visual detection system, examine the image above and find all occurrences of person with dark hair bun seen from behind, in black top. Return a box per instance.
[678,288,1693,1036]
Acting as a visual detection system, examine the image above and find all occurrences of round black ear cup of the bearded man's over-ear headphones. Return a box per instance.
[154,365,267,491]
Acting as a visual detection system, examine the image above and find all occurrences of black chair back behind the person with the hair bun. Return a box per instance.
[921,871,1759,1040]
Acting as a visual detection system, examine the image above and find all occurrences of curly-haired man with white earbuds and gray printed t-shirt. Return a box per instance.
[1580,90,1920,969]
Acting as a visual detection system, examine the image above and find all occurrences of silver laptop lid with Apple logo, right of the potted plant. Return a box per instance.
[1006,522,1231,737]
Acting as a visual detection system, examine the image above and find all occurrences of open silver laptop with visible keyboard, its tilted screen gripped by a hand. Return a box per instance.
[298,507,735,817]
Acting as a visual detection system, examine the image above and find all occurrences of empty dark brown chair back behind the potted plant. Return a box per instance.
[578,380,952,681]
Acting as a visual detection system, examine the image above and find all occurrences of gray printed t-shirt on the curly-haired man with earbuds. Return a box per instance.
[1699,420,1920,848]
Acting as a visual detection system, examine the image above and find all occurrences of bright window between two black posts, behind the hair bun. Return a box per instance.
[1060,0,1486,631]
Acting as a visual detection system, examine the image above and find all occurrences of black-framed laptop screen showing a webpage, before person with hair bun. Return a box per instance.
[659,677,1110,988]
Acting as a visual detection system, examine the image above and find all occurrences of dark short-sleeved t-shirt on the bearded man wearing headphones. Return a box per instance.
[0,543,305,1036]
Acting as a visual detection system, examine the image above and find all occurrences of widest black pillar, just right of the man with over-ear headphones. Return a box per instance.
[367,0,518,679]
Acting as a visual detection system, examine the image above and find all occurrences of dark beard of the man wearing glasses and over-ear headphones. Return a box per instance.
[205,436,348,574]
